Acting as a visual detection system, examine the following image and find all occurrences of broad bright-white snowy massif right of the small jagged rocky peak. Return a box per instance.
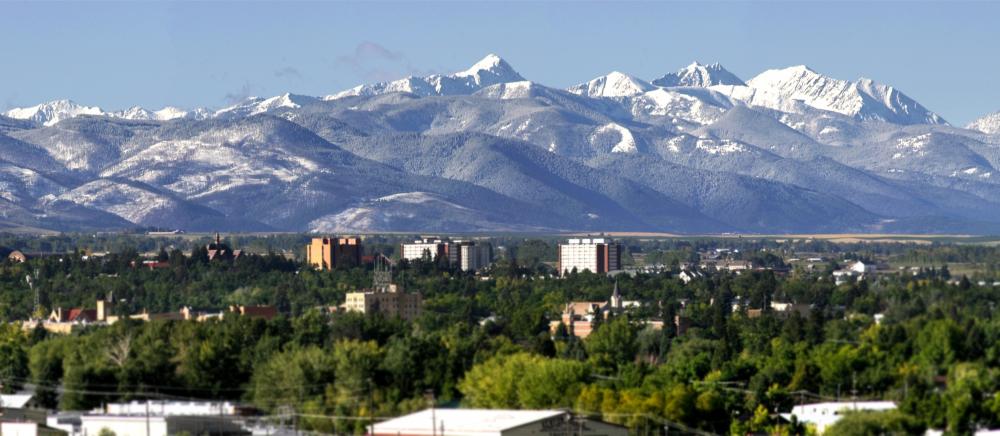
[712,65,947,124]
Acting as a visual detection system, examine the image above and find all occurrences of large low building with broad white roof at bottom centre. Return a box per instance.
[368,409,628,436]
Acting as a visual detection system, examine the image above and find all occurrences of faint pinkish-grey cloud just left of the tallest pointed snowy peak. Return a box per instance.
[334,41,434,81]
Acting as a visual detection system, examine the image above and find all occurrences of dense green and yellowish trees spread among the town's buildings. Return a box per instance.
[0,236,1000,434]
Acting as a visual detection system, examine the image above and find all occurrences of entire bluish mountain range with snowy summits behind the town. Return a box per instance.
[0,55,1000,233]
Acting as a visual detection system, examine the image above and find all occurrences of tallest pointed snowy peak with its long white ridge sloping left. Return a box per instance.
[324,53,524,100]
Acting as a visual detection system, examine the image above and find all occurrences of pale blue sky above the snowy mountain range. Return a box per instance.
[0,0,1000,125]
